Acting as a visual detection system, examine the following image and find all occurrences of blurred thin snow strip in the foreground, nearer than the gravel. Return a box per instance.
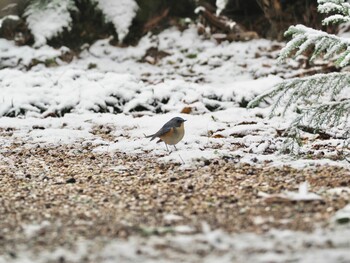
[0,223,350,263]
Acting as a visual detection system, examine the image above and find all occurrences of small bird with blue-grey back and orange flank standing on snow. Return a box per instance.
[146,117,186,151]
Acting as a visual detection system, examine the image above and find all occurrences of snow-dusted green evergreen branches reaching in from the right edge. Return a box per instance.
[248,0,350,148]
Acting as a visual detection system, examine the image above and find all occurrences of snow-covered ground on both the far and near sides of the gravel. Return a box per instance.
[0,27,350,262]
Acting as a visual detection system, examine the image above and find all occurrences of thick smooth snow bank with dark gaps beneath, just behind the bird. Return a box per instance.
[0,69,279,117]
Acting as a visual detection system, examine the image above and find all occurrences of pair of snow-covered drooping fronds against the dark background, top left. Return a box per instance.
[24,0,138,46]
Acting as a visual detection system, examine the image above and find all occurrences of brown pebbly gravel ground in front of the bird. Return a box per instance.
[0,139,350,262]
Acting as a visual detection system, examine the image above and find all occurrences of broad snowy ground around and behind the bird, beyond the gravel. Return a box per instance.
[0,26,347,168]
